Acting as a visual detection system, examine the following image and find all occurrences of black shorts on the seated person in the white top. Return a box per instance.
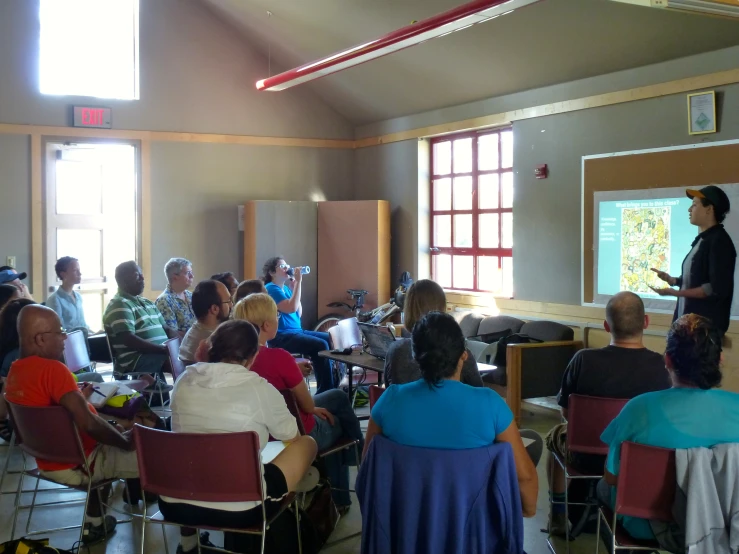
[159,458,288,529]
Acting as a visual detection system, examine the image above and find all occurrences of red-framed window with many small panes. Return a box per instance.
[431,128,513,296]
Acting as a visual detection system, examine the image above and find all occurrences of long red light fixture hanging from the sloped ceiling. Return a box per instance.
[256,0,541,91]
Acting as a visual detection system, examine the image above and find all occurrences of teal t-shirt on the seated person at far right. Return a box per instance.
[601,388,739,539]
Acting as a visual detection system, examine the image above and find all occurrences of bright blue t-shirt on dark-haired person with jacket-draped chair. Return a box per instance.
[372,379,513,450]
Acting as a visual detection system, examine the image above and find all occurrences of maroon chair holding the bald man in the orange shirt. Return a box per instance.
[6,397,131,541]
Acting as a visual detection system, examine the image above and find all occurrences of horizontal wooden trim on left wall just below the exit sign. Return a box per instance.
[0,123,354,149]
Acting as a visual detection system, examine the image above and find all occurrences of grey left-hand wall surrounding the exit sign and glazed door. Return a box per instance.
[0,0,353,298]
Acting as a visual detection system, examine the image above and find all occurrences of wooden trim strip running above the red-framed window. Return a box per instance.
[354,69,739,148]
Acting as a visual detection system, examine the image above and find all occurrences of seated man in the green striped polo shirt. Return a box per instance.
[103,261,177,375]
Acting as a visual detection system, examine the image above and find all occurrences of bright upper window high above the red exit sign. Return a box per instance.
[39,0,139,100]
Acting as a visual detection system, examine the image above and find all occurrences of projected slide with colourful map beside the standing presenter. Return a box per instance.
[596,197,697,301]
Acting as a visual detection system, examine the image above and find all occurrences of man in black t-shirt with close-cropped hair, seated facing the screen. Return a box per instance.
[546,292,670,536]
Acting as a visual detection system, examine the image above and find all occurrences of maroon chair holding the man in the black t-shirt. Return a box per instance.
[547,394,628,554]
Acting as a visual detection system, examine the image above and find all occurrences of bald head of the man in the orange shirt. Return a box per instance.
[18,304,67,360]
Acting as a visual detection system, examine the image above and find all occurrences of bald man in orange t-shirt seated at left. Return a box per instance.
[5,305,138,544]
